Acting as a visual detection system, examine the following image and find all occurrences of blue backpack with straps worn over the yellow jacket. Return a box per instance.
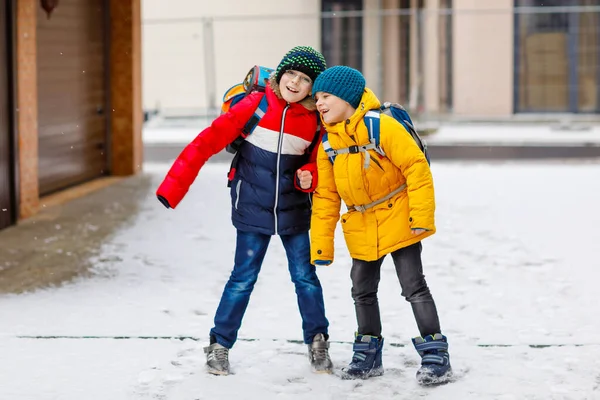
[322,102,431,169]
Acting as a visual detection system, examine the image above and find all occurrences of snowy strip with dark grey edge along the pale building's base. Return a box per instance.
[143,122,600,163]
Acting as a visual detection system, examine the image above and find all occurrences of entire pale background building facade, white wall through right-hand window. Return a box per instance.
[144,0,600,119]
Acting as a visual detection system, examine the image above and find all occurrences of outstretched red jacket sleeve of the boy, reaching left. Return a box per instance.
[156,93,264,208]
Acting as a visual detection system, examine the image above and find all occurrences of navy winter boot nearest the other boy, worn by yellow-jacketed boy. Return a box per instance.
[342,333,383,379]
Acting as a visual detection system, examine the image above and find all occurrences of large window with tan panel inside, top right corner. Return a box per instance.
[514,0,600,113]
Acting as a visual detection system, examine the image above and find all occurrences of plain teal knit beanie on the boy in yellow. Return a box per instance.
[312,65,366,108]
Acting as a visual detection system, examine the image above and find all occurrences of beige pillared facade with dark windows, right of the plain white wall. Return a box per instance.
[322,0,600,119]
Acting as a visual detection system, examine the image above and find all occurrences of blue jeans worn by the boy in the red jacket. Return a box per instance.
[210,230,329,348]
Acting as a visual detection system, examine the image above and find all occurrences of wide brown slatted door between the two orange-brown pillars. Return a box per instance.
[36,0,108,195]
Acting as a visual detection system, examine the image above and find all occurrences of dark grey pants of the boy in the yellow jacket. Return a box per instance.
[350,242,441,337]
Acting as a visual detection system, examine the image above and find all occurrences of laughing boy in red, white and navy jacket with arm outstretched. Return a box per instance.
[157,46,332,375]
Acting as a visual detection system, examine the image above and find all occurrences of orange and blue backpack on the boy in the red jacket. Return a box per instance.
[221,65,273,154]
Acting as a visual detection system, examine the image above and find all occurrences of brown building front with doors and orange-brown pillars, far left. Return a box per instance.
[0,0,142,229]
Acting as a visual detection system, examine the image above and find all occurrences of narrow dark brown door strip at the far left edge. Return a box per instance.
[0,0,15,229]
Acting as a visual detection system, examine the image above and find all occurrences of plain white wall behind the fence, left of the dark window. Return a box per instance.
[142,0,321,114]
